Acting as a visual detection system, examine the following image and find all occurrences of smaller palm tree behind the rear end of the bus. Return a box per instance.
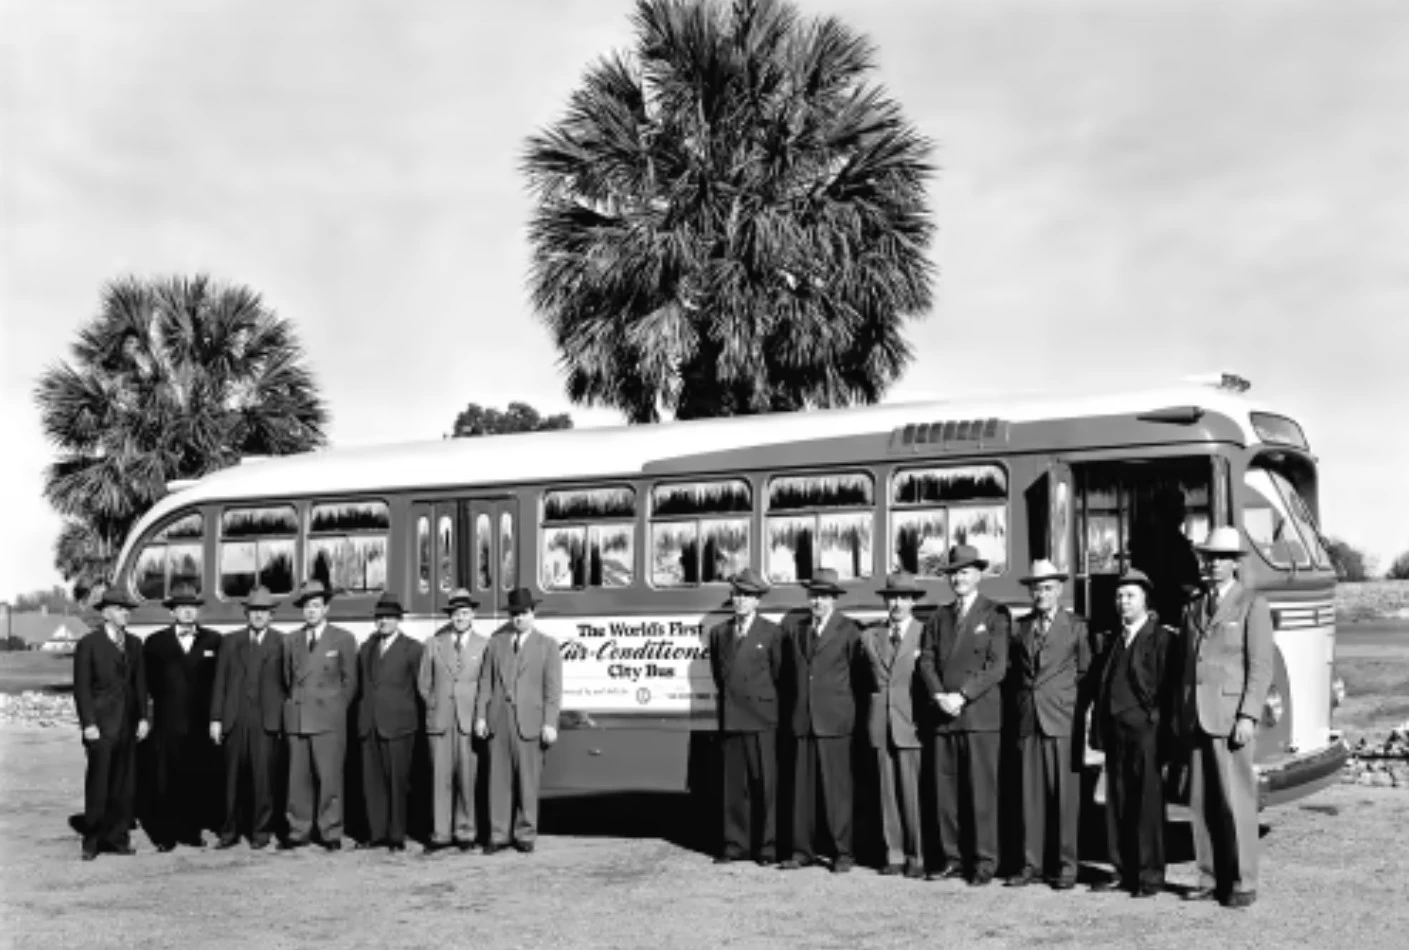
[35,275,328,588]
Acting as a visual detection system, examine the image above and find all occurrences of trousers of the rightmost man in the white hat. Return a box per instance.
[1189,730,1258,894]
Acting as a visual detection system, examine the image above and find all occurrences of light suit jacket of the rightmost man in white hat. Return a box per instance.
[1177,581,1277,736]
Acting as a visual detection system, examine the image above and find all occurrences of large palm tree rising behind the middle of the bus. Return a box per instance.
[523,0,934,421]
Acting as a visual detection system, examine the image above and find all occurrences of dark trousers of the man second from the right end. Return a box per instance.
[1103,719,1165,887]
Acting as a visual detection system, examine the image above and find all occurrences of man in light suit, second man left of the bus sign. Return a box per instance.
[417,588,489,854]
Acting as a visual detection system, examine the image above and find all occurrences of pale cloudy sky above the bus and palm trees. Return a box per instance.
[0,0,1409,598]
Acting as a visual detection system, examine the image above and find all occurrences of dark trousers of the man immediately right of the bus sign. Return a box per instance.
[720,733,778,861]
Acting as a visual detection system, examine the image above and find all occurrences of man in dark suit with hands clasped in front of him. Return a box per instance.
[920,544,1009,887]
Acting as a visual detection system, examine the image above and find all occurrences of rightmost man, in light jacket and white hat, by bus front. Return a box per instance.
[1177,527,1275,908]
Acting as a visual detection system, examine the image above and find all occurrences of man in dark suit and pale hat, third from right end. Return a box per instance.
[1007,561,1091,891]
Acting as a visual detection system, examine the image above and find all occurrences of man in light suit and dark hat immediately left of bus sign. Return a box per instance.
[475,588,562,854]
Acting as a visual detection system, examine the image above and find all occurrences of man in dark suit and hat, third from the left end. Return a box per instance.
[210,586,283,849]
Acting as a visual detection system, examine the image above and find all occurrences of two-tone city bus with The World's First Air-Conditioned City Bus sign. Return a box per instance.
[114,374,1347,805]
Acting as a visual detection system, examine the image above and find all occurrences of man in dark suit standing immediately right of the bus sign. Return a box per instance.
[709,568,783,864]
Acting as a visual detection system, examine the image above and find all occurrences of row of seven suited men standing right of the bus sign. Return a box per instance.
[709,527,1274,908]
